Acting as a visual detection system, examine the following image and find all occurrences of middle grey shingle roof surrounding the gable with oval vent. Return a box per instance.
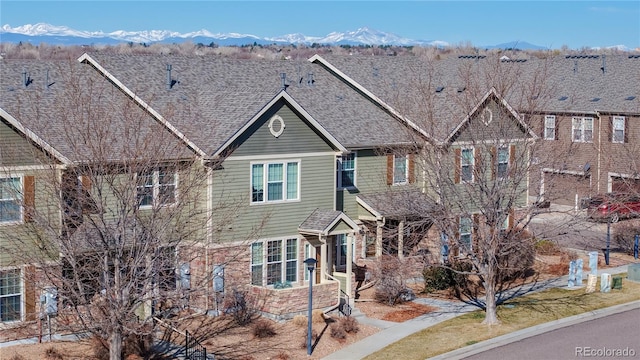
[82,54,418,154]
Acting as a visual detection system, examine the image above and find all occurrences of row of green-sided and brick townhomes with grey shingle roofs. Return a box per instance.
[0,52,640,344]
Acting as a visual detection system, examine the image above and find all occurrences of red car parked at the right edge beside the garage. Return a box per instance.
[587,193,640,223]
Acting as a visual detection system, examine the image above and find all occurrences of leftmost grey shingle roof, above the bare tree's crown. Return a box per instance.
[0,59,194,162]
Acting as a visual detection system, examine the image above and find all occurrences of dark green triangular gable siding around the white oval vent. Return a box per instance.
[232,105,333,156]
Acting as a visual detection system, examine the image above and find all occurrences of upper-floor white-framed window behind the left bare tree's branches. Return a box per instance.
[137,168,177,207]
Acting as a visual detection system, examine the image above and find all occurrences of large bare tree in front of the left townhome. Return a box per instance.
[0,61,250,359]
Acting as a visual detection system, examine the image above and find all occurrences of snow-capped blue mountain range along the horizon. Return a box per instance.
[0,23,568,50]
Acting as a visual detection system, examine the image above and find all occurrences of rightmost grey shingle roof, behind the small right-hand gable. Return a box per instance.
[322,55,640,140]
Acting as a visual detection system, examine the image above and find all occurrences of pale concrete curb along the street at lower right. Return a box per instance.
[429,300,640,360]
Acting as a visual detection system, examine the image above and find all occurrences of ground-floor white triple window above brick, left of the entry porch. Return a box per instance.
[251,239,298,286]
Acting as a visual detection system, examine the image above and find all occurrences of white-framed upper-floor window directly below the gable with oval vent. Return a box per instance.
[251,161,300,203]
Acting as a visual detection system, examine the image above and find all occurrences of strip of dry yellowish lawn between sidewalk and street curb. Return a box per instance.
[365,274,640,360]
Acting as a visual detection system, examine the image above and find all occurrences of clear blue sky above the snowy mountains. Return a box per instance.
[0,0,640,49]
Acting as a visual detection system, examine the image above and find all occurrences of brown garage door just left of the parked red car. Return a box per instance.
[544,172,592,206]
